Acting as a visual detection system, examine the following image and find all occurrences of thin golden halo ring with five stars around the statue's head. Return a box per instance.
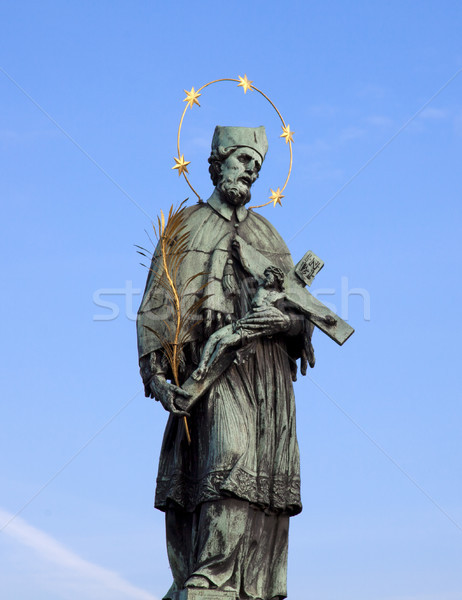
[172,75,294,208]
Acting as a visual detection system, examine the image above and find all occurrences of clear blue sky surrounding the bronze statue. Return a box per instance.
[0,0,462,600]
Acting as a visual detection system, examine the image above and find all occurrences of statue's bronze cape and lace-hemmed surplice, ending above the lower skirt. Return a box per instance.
[137,204,311,515]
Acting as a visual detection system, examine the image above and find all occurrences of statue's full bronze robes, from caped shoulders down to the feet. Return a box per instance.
[138,196,303,599]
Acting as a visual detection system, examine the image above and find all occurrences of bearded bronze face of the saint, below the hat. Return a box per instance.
[217,148,261,206]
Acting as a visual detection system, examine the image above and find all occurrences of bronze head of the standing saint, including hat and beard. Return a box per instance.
[209,126,268,206]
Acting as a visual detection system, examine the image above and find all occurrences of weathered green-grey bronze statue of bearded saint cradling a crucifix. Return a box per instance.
[138,127,318,600]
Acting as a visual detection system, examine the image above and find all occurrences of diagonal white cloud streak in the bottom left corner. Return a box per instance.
[0,508,158,600]
